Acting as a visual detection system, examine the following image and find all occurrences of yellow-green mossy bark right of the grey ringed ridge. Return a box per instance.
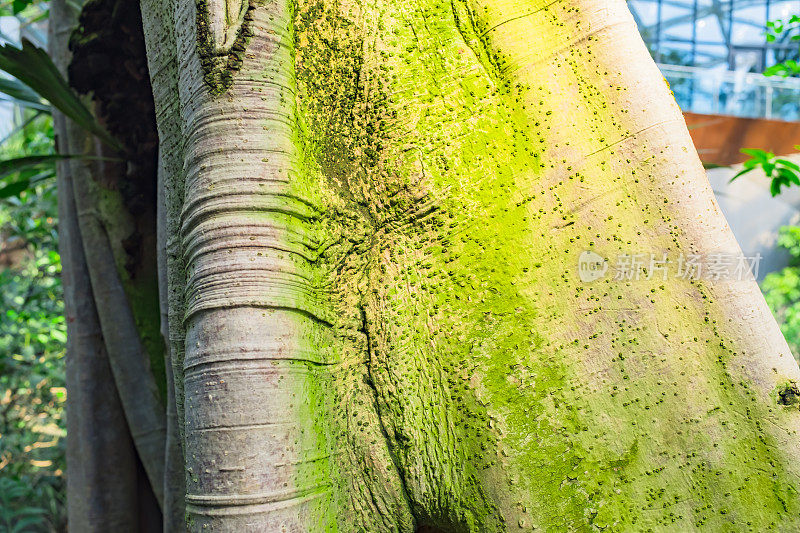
[183,0,800,531]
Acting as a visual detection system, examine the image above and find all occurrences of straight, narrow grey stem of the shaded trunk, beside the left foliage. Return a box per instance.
[49,0,139,532]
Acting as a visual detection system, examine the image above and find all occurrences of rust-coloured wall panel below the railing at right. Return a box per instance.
[683,113,800,165]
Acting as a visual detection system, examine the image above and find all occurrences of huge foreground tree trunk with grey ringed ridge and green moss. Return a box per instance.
[57,0,800,532]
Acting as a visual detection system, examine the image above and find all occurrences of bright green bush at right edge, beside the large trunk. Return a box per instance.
[761,226,800,358]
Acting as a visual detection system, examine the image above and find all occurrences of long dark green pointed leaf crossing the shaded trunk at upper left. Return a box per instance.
[0,38,123,151]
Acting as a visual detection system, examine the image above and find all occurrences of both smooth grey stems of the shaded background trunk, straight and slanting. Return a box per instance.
[50,0,165,532]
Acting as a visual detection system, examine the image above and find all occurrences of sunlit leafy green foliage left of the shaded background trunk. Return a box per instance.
[0,110,66,531]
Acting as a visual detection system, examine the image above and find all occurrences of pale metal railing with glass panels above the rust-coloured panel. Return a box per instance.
[659,64,800,121]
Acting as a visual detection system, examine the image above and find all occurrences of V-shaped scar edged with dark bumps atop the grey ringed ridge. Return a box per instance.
[195,0,257,96]
